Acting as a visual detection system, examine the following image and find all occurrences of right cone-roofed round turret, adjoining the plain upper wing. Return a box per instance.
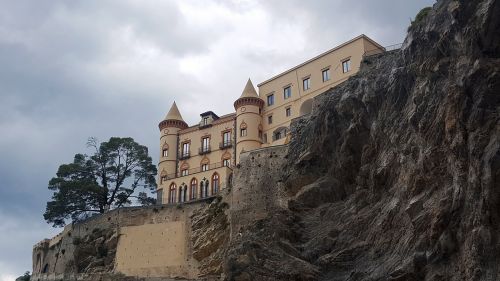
[234,79,264,163]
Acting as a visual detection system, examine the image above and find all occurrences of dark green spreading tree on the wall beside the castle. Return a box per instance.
[43,137,156,226]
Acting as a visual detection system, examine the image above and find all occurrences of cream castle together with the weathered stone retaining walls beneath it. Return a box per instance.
[32,35,385,280]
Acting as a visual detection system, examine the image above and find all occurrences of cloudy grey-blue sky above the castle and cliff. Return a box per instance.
[0,0,434,281]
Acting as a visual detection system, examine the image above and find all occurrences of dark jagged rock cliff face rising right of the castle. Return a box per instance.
[226,0,500,280]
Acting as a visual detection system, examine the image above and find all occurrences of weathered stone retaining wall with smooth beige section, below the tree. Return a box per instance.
[32,198,224,280]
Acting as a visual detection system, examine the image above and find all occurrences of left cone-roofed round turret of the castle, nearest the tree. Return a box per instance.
[158,102,188,184]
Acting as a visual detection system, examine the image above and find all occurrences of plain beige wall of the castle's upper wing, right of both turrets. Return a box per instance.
[258,36,380,147]
